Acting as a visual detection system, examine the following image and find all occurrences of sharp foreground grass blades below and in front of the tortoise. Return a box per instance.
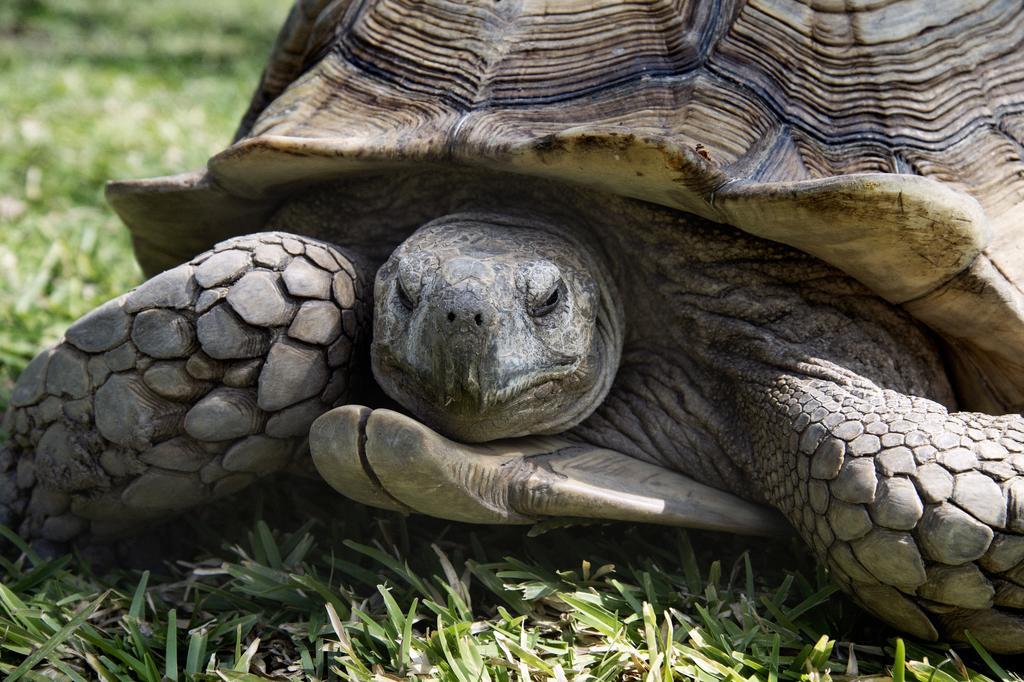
[0,495,1006,682]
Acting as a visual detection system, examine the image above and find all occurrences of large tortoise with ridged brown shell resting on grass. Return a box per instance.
[0,0,1024,652]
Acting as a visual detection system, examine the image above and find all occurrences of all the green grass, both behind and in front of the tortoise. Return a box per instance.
[0,0,1020,682]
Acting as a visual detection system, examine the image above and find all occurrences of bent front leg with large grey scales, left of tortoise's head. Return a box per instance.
[0,232,370,549]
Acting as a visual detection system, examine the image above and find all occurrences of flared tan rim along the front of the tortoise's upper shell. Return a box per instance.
[108,129,1024,412]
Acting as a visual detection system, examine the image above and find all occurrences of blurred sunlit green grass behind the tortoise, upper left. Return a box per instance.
[0,0,292,403]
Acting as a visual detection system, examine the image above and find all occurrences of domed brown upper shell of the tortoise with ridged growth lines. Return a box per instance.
[109,0,1024,413]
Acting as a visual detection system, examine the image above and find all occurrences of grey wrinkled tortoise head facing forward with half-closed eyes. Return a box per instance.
[371,214,622,442]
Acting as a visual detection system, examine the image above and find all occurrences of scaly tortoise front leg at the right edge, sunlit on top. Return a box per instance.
[743,376,1024,653]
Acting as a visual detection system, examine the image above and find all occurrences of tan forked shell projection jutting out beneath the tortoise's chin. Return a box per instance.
[309,406,791,536]
